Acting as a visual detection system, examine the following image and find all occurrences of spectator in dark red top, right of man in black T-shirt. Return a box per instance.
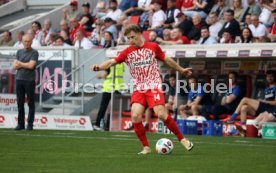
[188,14,207,43]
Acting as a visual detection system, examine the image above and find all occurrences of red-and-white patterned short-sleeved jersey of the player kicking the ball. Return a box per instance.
[115,42,165,91]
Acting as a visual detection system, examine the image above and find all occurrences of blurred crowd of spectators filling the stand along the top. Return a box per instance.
[0,0,276,49]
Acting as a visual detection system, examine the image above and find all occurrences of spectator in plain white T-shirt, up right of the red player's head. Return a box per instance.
[148,0,166,34]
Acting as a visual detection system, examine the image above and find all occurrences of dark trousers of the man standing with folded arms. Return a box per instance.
[16,80,35,127]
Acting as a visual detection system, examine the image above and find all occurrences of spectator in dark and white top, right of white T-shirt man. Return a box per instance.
[162,0,180,29]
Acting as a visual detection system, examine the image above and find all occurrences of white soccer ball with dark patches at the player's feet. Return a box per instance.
[155,138,173,154]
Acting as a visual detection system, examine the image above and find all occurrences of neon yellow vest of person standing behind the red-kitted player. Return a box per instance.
[103,63,124,93]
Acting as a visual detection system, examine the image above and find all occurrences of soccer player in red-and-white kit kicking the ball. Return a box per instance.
[91,25,193,154]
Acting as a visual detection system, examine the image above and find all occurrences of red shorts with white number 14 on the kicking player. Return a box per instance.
[130,89,165,108]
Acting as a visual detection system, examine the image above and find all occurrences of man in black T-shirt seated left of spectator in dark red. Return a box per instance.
[173,12,193,36]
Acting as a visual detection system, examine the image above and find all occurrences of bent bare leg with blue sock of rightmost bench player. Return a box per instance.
[230,97,260,121]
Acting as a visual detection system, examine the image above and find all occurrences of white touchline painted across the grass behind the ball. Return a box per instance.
[0,131,276,148]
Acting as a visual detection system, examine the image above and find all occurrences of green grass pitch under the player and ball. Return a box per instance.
[0,129,276,173]
